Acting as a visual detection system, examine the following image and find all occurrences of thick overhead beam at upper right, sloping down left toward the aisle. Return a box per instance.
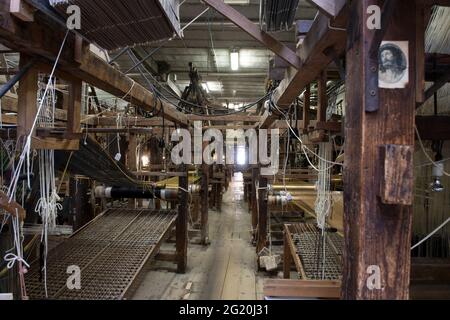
[274,5,348,107]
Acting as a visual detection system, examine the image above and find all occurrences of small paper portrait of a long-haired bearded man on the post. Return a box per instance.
[378,41,409,89]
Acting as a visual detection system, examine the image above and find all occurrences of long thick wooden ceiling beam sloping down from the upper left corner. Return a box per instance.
[0,1,187,124]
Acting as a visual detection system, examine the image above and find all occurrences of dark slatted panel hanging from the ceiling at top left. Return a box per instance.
[50,0,181,50]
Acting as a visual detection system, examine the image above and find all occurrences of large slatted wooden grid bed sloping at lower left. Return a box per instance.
[26,208,177,300]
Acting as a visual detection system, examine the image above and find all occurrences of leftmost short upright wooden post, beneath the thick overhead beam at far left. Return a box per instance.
[17,53,38,138]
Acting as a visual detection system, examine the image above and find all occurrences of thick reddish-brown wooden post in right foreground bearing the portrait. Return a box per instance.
[342,0,416,299]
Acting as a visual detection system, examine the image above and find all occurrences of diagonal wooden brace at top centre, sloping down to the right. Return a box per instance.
[203,0,302,69]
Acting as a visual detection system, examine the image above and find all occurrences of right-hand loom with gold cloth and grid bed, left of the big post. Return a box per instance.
[264,185,344,299]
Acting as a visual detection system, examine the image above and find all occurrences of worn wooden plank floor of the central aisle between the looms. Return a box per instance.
[133,172,263,300]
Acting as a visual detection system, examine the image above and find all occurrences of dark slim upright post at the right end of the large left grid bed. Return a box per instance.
[176,165,189,273]
